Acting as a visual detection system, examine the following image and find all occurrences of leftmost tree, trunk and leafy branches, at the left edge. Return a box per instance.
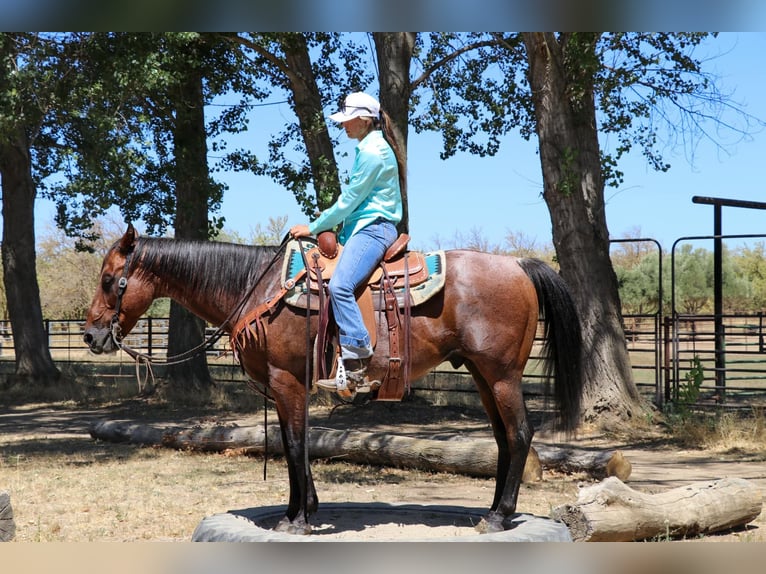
[0,34,174,392]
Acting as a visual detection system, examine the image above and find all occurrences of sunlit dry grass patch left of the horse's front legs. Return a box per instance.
[0,441,287,542]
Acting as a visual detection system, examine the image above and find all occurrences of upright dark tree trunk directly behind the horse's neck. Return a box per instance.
[165,51,212,403]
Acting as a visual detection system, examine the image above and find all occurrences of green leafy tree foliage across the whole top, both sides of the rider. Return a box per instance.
[10,32,756,248]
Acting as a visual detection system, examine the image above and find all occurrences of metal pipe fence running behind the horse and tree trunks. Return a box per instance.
[0,313,766,408]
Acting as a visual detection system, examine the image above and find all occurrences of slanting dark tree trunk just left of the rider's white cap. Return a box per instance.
[282,34,340,210]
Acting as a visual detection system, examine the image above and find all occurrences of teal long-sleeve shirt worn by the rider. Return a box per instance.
[309,130,402,244]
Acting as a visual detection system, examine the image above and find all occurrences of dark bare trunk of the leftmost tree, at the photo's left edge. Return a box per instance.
[0,131,60,387]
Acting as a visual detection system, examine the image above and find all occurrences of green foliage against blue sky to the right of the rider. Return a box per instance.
[412,32,763,193]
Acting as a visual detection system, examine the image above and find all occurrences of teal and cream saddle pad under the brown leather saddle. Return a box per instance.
[281,240,447,309]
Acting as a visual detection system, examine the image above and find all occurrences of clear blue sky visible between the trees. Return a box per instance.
[27,33,766,254]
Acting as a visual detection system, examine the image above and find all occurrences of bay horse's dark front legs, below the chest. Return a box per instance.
[269,369,319,534]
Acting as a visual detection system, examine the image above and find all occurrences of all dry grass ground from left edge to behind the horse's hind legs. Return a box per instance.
[0,396,578,542]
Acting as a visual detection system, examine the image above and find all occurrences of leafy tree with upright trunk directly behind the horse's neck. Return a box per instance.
[51,33,259,400]
